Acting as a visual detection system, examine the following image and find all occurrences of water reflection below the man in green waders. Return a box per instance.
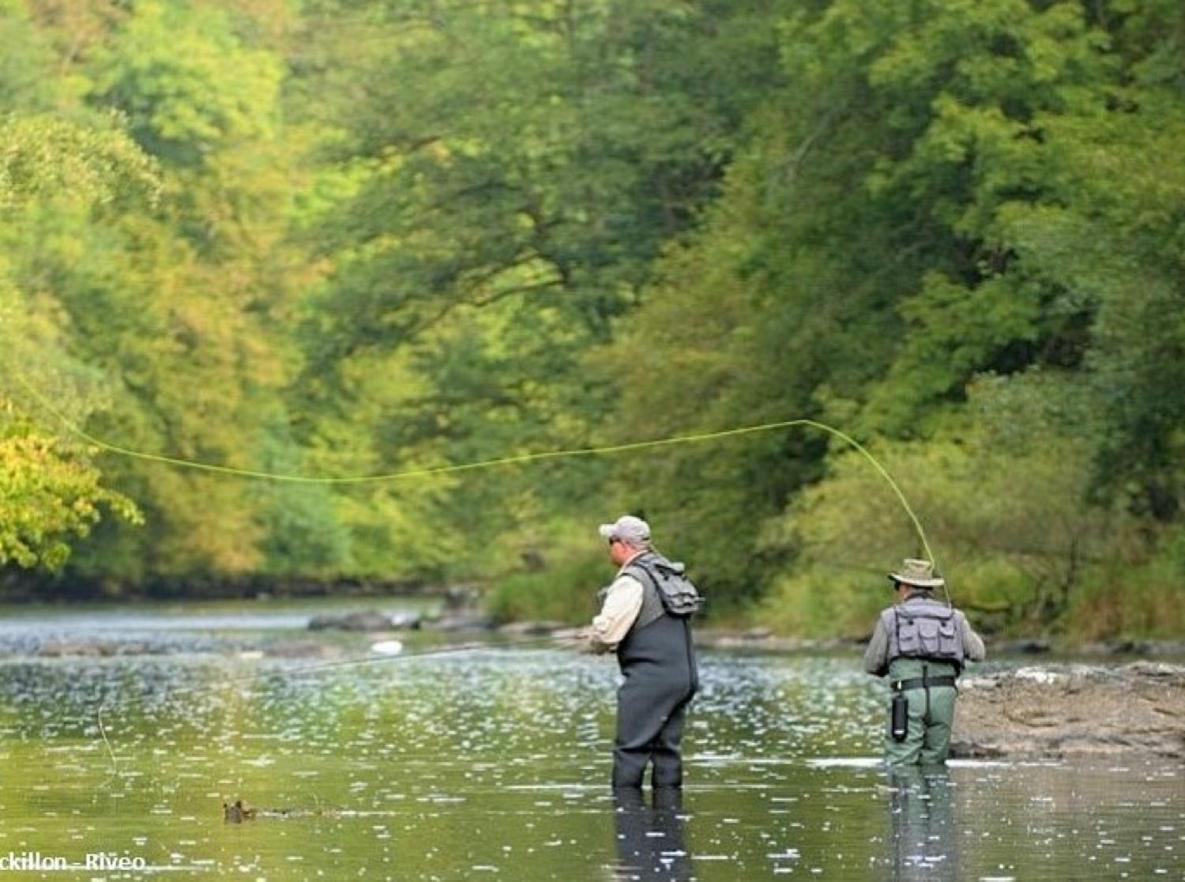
[886,766,962,882]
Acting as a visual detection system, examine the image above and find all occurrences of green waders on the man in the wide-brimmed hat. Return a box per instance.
[885,658,959,766]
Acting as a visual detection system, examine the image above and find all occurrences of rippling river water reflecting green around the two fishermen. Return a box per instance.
[0,605,1185,882]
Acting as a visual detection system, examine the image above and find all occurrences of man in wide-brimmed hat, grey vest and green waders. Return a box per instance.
[864,558,985,766]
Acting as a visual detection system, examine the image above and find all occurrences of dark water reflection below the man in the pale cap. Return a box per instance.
[613,787,692,882]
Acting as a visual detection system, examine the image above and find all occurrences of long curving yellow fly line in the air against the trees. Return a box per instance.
[12,372,937,563]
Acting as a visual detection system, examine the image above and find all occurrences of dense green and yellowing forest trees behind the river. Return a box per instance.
[0,0,1185,638]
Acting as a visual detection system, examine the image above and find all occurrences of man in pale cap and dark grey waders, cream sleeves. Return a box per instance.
[590,515,702,787]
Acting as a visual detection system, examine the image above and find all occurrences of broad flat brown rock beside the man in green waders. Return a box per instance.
[952,662,1185,758]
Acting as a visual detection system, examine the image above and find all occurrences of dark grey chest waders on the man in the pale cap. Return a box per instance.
[613,582,699,787]
